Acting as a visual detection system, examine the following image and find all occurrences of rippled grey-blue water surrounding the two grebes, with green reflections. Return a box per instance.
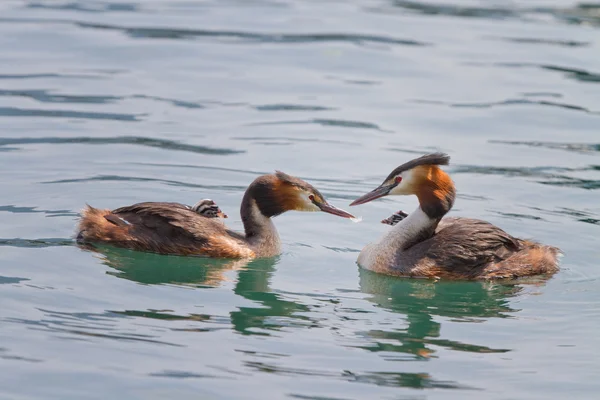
[0,0,600,400]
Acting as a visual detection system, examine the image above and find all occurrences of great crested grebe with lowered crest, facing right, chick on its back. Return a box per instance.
[77,171,354,258]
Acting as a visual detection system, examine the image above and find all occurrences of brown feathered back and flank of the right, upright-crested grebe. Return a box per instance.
[396,218,558,279]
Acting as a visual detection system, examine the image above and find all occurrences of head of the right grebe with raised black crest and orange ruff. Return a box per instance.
[350,153,454,211]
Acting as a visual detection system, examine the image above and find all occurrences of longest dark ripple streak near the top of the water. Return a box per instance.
[75,22,429,46]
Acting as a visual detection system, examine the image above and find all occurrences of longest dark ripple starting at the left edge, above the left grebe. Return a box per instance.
[0,138,245,155]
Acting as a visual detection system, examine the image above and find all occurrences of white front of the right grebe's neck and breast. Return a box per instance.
[358,206,437,271]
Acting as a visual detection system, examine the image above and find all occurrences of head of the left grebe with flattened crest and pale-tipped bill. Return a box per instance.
[248,171,354,218]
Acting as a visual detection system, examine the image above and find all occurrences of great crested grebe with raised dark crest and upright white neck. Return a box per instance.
[350,153,560,280]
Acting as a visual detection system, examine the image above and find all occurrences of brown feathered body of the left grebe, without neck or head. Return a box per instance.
[78,202,254,258]
